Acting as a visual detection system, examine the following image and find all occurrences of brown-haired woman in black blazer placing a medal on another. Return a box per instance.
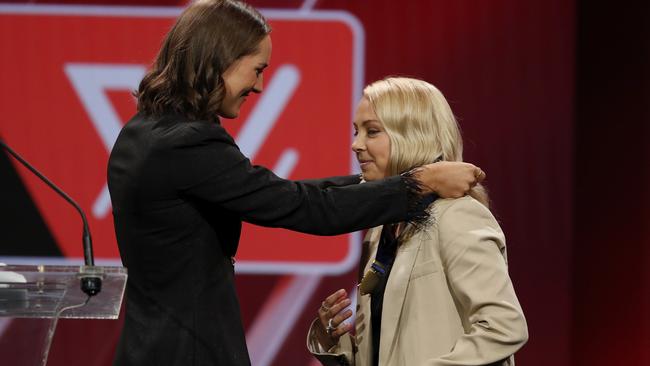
[108,0,483,366]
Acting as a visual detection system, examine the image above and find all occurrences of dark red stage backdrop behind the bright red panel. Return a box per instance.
[0,0,650,365]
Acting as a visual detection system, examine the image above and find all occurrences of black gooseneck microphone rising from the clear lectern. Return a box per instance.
[0,139,102,296]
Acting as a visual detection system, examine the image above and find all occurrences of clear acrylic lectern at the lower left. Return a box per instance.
[0,265,127,365]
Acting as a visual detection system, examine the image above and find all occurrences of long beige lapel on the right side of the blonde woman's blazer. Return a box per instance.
[379,233,422,365]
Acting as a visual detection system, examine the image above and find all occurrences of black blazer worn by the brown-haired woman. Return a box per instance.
[108,114,420,366]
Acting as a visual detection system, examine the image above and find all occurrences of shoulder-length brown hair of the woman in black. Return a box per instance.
[135,0,271,120]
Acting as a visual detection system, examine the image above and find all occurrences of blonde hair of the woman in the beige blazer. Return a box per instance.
[363,77,489,206]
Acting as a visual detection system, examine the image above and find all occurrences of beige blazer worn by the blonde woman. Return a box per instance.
[307,196,528,366]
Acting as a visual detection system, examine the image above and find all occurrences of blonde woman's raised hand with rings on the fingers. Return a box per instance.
[314,289,352,350]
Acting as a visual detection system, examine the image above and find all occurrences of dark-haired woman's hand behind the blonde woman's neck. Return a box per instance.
[413,161,485,198]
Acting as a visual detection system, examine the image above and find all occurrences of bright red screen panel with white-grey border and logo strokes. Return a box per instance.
[0,7,363,273]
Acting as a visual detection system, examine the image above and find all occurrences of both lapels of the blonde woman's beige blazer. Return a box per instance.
[359,226,426,365]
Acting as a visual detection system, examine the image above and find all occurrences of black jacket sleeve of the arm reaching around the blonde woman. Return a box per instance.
[165,122,413,235]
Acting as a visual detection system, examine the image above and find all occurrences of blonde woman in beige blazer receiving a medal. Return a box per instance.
[307,78,528,366]
